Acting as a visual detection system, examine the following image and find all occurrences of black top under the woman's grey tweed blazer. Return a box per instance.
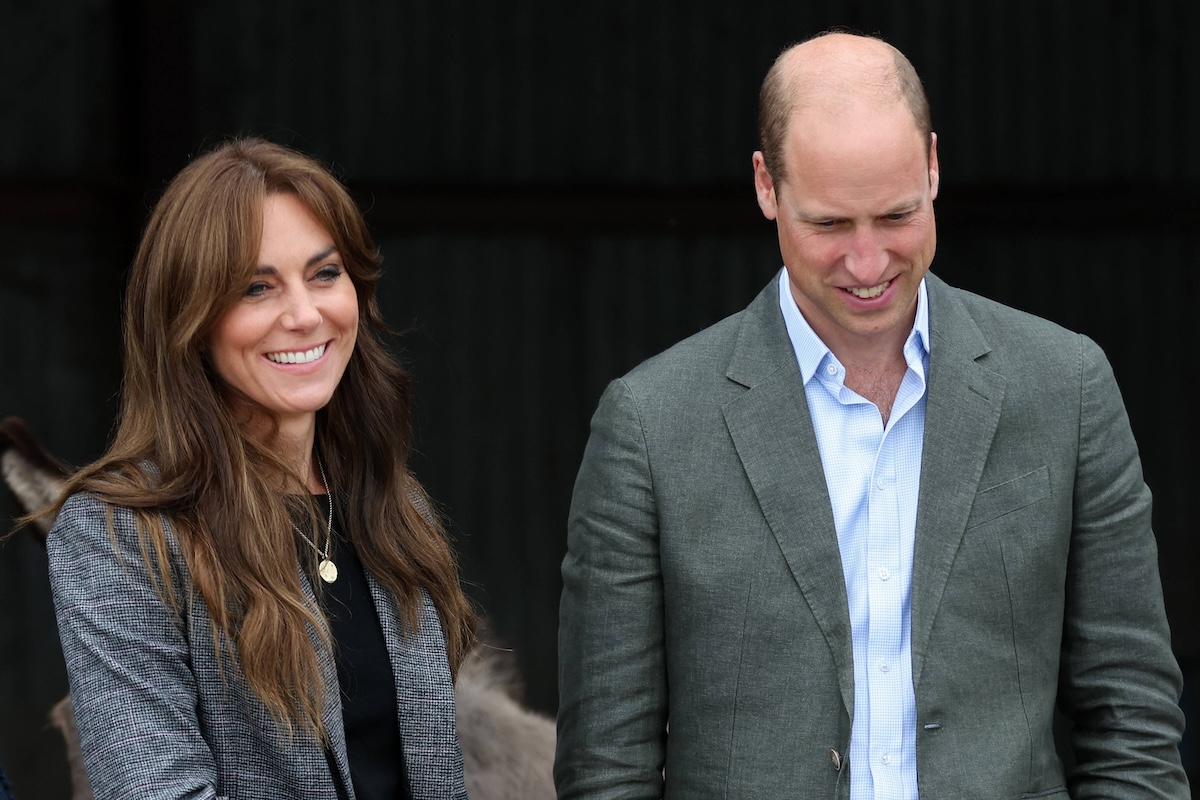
[304,495,412,800]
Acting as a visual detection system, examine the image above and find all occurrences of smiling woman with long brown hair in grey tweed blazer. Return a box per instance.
[48,139,474,800]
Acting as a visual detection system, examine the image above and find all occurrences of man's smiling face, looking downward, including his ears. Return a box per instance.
[754,102,938,359]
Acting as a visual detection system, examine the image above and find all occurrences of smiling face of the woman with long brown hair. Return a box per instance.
[209,194,359,434]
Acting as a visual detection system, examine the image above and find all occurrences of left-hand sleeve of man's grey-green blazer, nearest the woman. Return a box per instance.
[554,380,667,800]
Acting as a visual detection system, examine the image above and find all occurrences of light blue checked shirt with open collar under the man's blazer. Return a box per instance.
[779,270,929,800]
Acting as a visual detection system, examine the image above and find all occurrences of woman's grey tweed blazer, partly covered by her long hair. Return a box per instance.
[47,495,467,800]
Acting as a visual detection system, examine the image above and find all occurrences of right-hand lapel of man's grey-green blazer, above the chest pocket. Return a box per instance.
[912,275,1004,685]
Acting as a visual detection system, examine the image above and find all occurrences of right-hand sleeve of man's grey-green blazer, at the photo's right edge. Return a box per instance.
[1058,338,1190,799]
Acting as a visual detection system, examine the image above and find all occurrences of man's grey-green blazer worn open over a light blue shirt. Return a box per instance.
[554,275,1189,800]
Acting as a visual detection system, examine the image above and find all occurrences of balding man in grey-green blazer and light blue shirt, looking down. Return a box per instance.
[556,34,1188,800]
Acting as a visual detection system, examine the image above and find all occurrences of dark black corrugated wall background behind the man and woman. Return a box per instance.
[0,0,1200,800]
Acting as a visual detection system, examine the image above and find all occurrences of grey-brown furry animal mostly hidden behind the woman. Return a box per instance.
[0,417,554,800]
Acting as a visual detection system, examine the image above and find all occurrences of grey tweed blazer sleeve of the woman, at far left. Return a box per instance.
[47,495,226,800]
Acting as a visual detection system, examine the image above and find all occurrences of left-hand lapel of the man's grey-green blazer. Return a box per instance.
[724,281,854,710]
